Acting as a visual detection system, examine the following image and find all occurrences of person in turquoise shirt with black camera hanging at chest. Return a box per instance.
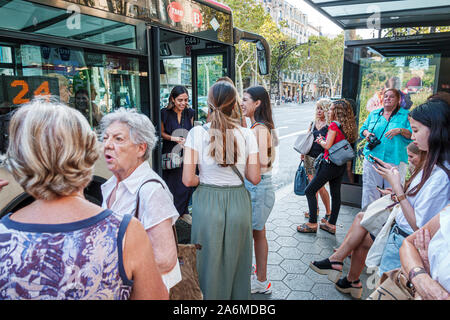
[359,89,412,208]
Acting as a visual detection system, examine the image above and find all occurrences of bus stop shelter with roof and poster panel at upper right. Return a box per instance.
[305,0,450,207]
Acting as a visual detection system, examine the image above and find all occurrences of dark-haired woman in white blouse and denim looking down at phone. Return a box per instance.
[374,100,450,275]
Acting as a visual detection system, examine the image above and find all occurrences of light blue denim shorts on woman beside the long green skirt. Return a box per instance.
[245,175,275,230]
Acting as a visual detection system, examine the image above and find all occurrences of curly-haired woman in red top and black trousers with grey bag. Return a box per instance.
[297,100,357,234]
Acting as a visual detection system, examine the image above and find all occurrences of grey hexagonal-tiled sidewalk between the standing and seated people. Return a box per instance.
[252,184,374,300]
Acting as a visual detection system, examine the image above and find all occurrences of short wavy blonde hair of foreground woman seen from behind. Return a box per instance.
[6,98,99,200]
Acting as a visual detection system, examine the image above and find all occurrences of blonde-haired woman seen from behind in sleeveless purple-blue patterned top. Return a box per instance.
[0,100,168,300]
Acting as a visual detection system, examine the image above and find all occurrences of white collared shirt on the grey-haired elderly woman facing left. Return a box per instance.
[101,161,181,290]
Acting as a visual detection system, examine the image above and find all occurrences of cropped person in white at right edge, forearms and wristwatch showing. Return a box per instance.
[400,204,450,300]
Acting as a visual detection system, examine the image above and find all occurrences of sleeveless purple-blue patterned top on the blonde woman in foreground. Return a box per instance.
[0,210,133,300]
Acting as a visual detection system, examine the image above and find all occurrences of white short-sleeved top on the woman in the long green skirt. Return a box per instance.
[184,123,258,186]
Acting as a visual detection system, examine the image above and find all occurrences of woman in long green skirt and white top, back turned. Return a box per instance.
[183,81,261,300]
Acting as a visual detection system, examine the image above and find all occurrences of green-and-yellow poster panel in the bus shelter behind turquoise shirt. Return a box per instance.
[354,55,440,174]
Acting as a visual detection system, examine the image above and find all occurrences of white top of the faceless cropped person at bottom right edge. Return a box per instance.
[428,205,450,292]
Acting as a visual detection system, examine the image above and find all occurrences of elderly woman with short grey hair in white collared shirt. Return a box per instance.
[100,108,181,289]
